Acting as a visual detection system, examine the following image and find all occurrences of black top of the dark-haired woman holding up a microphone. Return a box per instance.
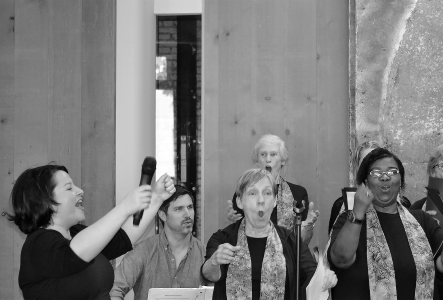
[18,225,132,300]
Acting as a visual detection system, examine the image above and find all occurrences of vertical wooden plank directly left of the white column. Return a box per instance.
[81,0,116,224]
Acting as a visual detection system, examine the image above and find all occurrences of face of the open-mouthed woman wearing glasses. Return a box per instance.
[367,157,401,207]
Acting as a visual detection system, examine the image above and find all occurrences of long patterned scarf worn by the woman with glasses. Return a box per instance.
[366,202,434,300]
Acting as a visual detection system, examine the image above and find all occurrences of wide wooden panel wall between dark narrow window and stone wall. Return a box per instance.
[203,0,349,246]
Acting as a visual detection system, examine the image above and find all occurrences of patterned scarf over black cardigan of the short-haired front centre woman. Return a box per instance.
[226,218,286,300]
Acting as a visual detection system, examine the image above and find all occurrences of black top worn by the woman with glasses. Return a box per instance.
[328,210,443,300]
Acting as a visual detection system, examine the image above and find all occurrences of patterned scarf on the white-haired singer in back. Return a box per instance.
[277,176,294,231]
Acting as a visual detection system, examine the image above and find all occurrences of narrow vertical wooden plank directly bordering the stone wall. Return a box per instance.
[317,0,350,245]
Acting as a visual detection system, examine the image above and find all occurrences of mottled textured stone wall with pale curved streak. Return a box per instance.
[350,0,443,202]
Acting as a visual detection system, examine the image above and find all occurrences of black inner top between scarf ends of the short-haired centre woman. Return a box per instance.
[246,236,268,300]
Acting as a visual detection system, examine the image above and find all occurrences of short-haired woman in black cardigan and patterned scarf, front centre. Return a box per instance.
[202,169,336,299]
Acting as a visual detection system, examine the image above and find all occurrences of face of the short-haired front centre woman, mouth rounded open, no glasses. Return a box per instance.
[237,177,276,227]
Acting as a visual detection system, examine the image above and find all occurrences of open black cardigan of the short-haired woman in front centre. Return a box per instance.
[205,220,317,300]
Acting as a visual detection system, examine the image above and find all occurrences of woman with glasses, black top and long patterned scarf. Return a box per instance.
[328,148,443,300]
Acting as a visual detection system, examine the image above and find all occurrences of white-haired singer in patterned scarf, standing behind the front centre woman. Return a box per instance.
[228,134,319,244]
